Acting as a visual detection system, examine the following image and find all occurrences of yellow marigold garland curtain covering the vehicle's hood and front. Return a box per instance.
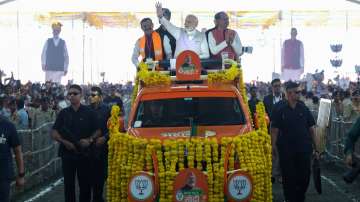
[107,130,272,202]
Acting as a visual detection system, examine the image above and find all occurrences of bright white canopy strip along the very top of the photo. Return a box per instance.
[0,0,360,12]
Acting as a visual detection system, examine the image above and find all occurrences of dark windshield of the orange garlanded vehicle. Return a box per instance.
[132,97,245,128]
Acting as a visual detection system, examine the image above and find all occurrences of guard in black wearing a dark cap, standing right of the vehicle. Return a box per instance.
[271,81,315,202]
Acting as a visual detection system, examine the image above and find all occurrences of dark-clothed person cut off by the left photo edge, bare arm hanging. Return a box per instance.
[0,116,25,202]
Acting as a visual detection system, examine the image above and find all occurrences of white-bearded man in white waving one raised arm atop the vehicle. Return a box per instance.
[156,3,209,59]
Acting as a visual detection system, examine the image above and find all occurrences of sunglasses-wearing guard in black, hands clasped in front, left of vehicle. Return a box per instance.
[52,84,101,202]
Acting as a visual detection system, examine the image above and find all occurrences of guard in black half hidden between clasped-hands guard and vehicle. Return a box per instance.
[90,86,110,202]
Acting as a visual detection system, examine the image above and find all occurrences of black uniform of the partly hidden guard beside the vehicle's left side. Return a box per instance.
[91,104,110,202]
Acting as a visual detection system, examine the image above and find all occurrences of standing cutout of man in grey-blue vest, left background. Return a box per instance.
[41,22,69,83]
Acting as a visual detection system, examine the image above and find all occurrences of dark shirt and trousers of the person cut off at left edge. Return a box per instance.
[0,117,20,202]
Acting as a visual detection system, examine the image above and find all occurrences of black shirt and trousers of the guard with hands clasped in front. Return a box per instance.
[53,105,98,202]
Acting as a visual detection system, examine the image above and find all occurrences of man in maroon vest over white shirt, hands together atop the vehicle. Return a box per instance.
[208,11,243,60]
